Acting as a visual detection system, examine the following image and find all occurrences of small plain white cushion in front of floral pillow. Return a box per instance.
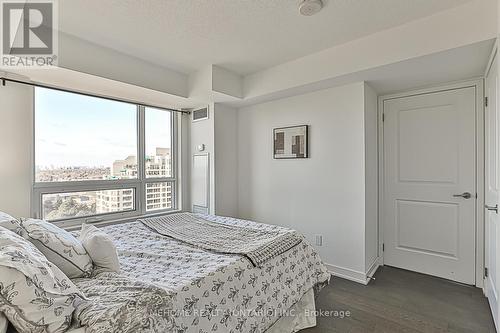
[80,224,120,273]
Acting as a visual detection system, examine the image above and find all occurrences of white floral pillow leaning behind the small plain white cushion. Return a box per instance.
[20,219,92,279]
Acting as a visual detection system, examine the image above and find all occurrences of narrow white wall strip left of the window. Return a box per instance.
[0,82,33,217]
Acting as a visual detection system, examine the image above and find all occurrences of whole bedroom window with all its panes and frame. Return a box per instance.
[33,87,177,221]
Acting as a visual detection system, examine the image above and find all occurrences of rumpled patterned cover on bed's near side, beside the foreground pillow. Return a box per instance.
[73,273,173,333]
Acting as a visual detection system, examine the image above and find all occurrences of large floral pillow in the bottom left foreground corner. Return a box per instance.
[0,227,84,333]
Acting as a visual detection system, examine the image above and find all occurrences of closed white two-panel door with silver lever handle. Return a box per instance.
[384,87,476,284]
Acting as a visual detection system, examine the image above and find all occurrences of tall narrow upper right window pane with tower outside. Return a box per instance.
[145,108,172,178]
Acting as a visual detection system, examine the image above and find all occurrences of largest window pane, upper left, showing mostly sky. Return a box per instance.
[35,88,137,182]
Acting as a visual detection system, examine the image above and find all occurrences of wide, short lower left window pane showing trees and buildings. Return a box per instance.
[42,188,135,221]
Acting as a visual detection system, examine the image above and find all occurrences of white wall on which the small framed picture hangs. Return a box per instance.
[238,82,376,280]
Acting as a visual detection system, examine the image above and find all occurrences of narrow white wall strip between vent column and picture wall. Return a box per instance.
[214,103,238,217]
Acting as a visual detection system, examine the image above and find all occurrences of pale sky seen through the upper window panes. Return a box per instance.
[35,87,171,168]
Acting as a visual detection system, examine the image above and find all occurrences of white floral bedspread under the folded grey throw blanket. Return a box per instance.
[74,216,330,333]
